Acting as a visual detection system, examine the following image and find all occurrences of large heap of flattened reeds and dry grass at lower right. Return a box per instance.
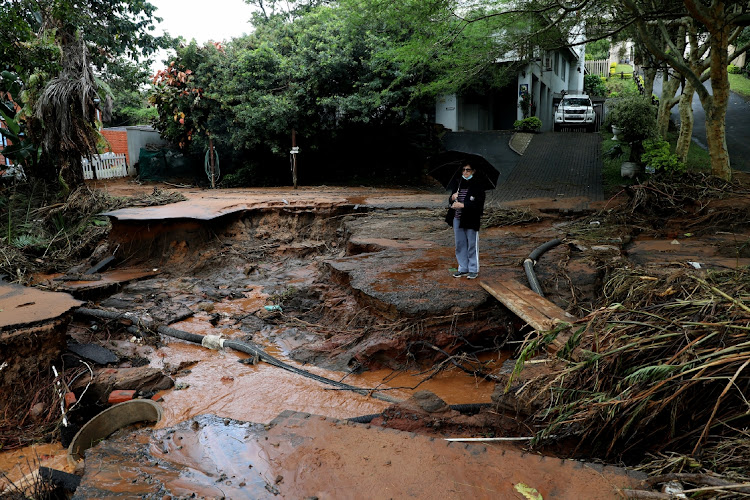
[512,269,750,477]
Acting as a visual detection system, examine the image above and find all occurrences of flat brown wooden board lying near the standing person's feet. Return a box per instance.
[480,280,575,330]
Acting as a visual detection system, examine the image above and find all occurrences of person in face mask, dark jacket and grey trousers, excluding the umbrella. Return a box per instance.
[445,164,485,279]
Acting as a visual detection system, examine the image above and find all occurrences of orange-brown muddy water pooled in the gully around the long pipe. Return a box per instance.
[156,312,503,428]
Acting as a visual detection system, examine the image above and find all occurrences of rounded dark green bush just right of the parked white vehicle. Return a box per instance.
[605,94,657,142]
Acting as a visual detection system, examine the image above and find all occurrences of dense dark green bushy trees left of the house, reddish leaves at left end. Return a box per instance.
[151,6,444,185]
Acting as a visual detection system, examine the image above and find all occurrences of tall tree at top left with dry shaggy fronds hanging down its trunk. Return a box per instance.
[0,0,170,189]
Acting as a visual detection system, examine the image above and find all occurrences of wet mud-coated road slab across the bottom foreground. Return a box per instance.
[74,411,645,500]
